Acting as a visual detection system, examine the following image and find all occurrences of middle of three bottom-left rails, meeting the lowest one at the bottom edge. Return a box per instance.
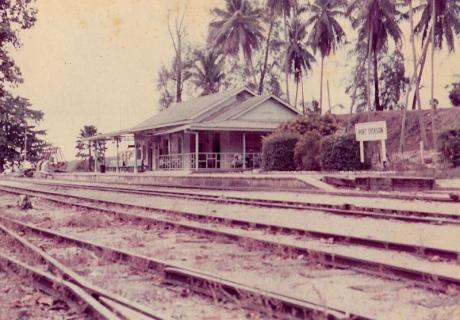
[0,224,169,320]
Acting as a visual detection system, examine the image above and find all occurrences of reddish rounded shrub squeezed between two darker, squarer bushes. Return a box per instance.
[294,131,321,171]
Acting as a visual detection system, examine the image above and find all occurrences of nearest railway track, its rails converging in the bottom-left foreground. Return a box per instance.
[0,217,364,320]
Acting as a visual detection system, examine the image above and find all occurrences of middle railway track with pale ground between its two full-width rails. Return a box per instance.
[0,182,460,291]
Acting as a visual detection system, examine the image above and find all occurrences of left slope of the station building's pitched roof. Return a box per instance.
[132,87,254,131]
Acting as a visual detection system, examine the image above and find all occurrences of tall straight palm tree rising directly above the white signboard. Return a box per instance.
[348,0,402,111]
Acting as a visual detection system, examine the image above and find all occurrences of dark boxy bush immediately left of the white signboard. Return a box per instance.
[320,134,370,171]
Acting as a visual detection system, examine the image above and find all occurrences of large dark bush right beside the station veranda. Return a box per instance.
[262,132,299,171]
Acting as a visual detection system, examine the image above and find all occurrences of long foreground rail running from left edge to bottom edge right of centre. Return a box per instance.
[0,216,370,320]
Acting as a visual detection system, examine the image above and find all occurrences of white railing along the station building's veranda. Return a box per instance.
[157,152,262,170]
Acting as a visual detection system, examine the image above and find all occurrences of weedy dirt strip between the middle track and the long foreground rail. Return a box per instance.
[0,191,460,319]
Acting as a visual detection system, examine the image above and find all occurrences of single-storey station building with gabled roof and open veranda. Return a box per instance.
[89,88,299,172]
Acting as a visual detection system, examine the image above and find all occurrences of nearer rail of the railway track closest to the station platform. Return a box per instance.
[4,179,460,225]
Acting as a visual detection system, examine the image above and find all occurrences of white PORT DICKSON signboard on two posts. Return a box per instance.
[355,121,387,163]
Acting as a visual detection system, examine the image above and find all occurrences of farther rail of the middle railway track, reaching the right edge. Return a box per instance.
[0,187,460,260]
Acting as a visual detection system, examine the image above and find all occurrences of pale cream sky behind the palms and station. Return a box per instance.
[12,0,460,160]
